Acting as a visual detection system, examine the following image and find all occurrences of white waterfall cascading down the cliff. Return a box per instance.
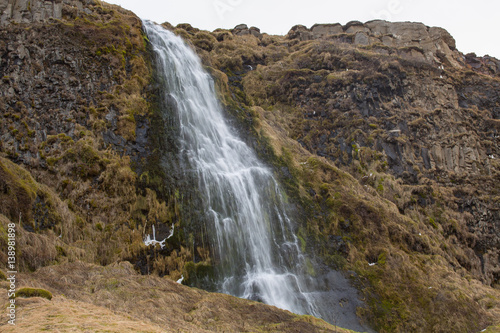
[143,21,370,330]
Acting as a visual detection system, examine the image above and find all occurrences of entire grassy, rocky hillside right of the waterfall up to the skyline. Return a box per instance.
[168,21,500,332]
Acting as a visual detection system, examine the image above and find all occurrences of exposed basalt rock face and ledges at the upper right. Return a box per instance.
[287,21,500,285]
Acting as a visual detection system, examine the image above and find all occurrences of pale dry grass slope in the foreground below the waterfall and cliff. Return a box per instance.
[4,262,356,332]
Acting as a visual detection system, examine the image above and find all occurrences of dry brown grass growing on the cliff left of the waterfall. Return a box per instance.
[0,3,195,278]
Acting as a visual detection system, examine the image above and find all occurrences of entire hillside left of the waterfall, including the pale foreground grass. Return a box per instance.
[0,0,352,332]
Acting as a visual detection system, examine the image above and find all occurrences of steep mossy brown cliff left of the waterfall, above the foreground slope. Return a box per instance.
[0,1,199,280]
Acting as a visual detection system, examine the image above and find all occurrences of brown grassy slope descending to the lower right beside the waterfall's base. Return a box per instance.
[233,101,500,332]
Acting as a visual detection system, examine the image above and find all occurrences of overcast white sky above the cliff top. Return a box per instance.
[105,0,500,59]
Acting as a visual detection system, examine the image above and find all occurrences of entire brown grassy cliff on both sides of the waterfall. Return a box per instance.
[0,0,500,332]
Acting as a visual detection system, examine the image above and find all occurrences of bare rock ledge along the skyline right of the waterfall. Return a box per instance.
[231,20,500,75]
